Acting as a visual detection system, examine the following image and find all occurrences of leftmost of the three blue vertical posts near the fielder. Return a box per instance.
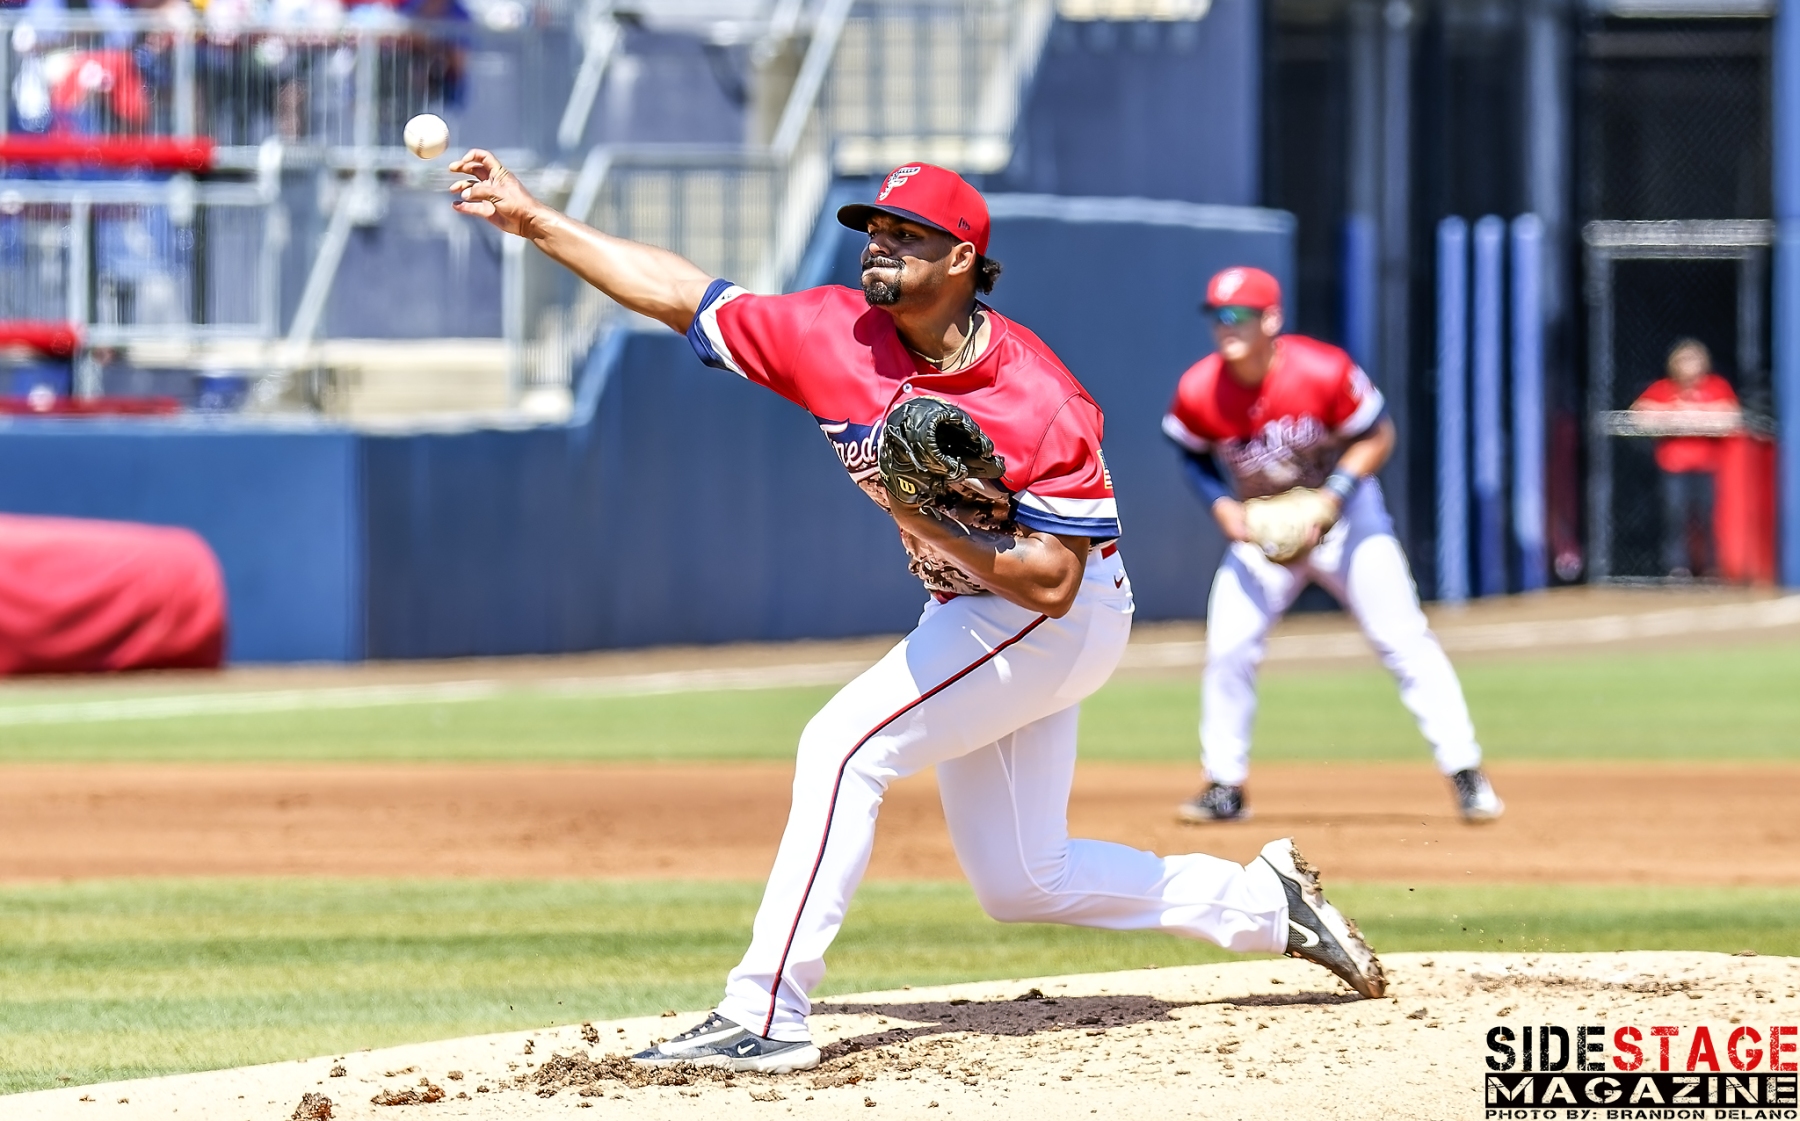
[1438,218,1469,603]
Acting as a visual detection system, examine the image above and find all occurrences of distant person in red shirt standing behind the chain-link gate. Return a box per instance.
[1631,338,1741,579]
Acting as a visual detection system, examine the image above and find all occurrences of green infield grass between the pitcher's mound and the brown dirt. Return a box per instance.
[0,880,1800,1112]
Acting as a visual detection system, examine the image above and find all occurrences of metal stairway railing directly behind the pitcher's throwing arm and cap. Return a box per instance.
[520,0,1057,403]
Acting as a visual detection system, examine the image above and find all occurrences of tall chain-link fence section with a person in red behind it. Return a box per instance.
[1575,7,1773,579]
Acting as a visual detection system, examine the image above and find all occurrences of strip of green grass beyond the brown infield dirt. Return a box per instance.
[0,642,1800,761]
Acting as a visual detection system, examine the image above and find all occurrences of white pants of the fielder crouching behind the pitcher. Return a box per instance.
[1201,479,1481,786]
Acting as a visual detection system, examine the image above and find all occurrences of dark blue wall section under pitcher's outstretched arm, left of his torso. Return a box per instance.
[367,331,923,659]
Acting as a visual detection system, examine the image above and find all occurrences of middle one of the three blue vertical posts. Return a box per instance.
[1471,214,1507,596]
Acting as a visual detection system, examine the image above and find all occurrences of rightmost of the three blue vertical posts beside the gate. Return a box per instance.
[1512,214,1550,592]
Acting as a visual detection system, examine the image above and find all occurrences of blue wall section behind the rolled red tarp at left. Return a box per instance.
[0,419,364,662]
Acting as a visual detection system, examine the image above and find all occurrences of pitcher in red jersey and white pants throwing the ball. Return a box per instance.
[450,151,1384,1074]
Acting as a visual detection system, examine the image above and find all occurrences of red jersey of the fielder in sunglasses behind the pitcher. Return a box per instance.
[1163,335,1384,498]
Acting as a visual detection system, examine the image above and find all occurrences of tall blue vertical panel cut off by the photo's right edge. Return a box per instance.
[1773,4,1800,588]
